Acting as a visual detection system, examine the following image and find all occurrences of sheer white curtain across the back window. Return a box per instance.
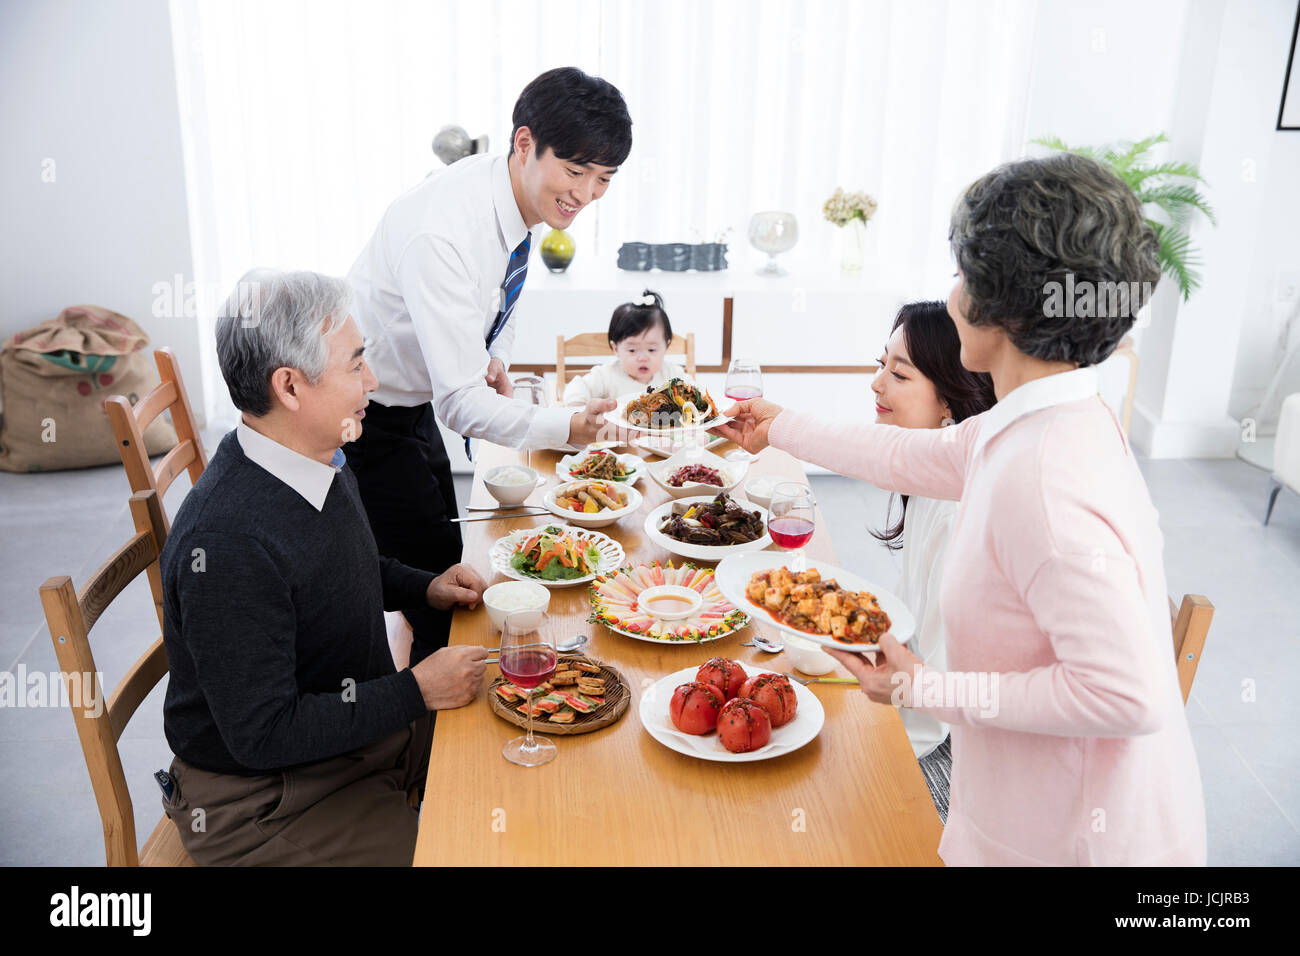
[172,0,1035,416]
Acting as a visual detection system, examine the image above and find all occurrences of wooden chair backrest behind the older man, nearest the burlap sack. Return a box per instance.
[105,349,208,528]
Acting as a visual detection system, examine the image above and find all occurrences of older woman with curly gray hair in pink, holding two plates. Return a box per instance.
[718,155,1205,865]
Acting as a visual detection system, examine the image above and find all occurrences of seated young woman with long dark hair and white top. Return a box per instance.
[871,302,997,819]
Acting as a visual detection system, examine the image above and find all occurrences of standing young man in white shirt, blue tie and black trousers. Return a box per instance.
[346,66,632,663]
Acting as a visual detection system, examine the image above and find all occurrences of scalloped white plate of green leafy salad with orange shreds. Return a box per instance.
[488,524,624,588]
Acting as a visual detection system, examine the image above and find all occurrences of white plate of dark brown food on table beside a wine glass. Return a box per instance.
[645,492,772,561]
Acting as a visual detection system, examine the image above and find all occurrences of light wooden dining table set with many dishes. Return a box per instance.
[415,444,943,866]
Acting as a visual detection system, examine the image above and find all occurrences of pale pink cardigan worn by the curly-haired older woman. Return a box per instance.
[770,369,1205,866]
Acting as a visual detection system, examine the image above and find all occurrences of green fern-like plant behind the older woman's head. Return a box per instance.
[1030,133,1217,302]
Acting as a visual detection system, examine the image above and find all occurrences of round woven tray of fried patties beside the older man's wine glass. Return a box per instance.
[488,654,632,734]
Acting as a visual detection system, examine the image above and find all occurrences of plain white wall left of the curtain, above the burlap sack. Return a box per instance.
[0,0,202,414]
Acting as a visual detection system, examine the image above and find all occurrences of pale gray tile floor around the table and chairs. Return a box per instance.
[0,433,1300,866]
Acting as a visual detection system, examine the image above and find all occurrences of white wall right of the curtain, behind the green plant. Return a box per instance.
[1027,0,1300,457]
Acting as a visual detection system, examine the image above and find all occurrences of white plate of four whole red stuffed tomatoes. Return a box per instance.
[638,657,826,763]
